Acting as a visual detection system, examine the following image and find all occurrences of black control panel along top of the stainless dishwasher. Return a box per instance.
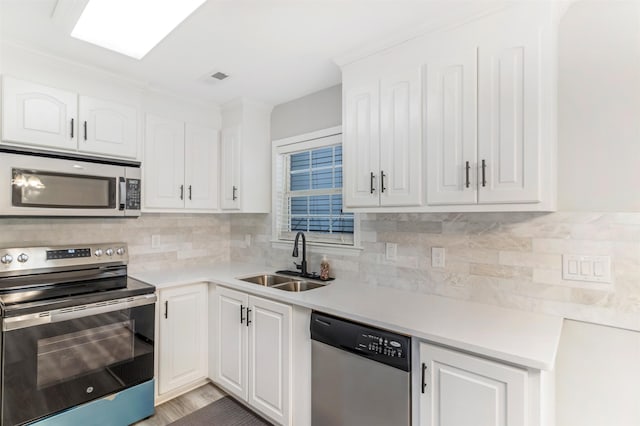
[311,312,411,371]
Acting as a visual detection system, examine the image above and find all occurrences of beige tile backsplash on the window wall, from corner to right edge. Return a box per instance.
[230,212,640,330]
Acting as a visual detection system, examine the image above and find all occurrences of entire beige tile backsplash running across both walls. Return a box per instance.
[0,212,640,330]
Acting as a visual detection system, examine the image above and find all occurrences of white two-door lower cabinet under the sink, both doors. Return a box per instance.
[212,287,292,425]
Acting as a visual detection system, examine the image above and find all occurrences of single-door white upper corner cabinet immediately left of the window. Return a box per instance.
[220,99,271,213]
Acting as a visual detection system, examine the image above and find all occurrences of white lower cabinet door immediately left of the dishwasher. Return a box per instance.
[249,296,291,425]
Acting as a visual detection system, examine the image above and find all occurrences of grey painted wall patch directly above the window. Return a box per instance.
[271,85,342,140]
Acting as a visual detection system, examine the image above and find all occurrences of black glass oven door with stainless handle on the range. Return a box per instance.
[1,294,156,425]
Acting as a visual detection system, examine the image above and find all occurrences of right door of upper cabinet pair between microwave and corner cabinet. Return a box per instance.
[184,124,220,210]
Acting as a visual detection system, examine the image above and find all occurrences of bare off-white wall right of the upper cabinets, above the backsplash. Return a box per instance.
[558,1,640,212]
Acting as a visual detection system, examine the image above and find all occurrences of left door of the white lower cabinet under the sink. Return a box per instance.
[215,287,249,401]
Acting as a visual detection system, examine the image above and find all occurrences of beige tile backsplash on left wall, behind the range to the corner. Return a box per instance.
[0,213,229,272]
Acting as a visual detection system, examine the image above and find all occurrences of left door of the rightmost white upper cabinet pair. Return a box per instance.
[425,45,478,205]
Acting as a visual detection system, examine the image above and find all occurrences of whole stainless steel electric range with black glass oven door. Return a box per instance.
[0,243,156,426]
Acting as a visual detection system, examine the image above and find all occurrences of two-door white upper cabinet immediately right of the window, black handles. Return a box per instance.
[343,65,422,208]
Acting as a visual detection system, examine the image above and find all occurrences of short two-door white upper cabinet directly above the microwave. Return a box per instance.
[2,76,138,158]
